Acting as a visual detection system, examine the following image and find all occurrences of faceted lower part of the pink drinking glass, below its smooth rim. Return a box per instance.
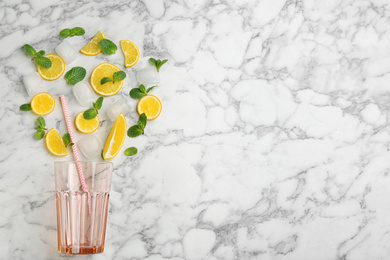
[56,190,109,254]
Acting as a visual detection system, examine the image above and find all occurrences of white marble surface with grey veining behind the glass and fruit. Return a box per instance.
[0,0,390,260]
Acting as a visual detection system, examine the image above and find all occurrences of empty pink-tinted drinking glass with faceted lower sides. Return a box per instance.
[54,161,113,255]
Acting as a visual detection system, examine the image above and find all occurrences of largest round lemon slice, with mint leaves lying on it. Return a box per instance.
[91,62,124,96]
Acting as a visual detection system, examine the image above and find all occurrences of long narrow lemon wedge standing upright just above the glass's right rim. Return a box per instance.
[103,113,126,160]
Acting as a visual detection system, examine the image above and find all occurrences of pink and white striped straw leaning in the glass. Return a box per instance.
[60,95,91,214]
